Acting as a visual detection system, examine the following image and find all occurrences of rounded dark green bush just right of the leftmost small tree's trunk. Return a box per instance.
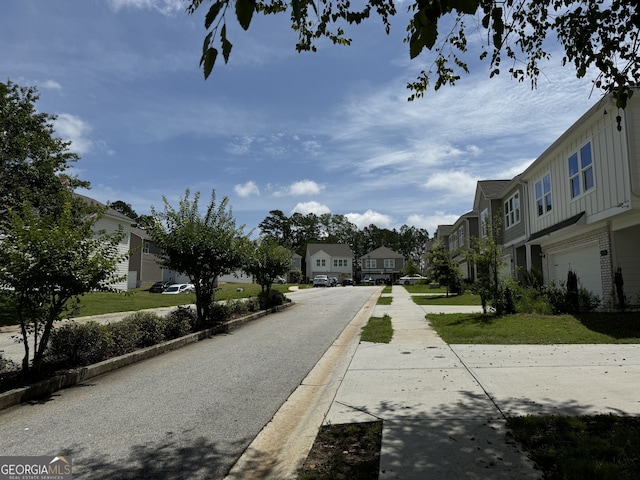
[45,322,113,368]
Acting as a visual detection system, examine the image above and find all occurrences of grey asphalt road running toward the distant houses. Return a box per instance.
[0,287,376,480]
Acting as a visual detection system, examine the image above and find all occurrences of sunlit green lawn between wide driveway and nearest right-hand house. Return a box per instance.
[427,313,640,345]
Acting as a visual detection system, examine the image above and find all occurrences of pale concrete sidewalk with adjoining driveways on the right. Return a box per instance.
[324,286,640,480]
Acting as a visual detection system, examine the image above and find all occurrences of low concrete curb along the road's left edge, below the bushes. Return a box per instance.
[0,302,294,410]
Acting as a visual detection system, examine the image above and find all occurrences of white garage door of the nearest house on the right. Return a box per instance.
[549,243,603,298]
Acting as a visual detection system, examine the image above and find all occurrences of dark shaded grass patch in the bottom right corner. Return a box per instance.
[507,415,640,480]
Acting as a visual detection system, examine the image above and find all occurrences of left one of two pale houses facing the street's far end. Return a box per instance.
[305,243,353,280]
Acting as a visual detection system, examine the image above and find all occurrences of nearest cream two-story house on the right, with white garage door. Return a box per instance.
[520,92,640,304]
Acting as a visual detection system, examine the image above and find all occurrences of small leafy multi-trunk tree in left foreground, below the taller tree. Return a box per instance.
[0,192,124,377]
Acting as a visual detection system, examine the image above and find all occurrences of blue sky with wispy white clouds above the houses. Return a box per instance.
[0,0,600,236]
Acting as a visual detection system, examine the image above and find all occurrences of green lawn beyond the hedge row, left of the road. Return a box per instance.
[0,283,289,326]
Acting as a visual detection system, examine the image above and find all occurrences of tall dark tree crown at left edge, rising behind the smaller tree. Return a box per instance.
[0,81,89,224]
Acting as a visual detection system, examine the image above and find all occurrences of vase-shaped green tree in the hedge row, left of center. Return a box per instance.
[147,189,249,324]
